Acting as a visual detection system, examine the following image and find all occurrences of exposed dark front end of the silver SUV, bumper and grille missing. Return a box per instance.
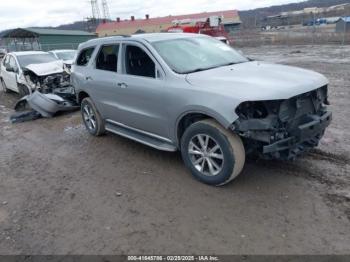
[232,86,332,160]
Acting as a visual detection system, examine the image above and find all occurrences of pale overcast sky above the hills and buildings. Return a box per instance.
[0,0,302,30]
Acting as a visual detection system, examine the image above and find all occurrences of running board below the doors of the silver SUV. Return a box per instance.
[106,120,177,152]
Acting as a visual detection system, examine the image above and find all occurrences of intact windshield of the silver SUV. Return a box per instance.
[152,37,249,74]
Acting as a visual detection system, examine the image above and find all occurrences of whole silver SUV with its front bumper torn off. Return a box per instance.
[71,33,332,186]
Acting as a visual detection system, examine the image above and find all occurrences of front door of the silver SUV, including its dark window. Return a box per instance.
[108,42,169,138]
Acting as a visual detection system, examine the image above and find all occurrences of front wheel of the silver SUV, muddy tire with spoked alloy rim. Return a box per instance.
[181,119,245,186]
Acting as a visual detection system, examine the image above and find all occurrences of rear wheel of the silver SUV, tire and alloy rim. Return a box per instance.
[81,97,106,136]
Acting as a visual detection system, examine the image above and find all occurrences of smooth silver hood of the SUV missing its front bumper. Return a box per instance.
[186,61,328,101]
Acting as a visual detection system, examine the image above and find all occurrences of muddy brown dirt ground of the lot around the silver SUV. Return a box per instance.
[0,46,350,255]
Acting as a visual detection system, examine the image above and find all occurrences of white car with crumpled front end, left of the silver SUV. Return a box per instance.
[0,51,63,96]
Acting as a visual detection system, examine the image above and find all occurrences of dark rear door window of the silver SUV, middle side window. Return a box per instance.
[96,44,119,72]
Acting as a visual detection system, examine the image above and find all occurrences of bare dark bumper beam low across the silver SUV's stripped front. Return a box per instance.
[262,112,332,160]
